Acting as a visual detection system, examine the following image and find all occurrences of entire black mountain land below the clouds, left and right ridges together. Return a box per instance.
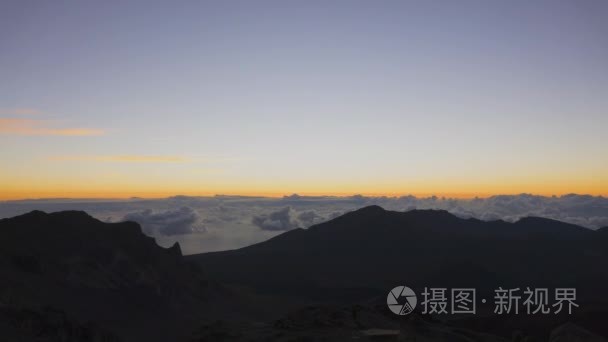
[0,206,608,342]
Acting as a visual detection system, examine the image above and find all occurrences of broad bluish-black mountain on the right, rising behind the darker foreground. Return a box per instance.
[187,206,608,307]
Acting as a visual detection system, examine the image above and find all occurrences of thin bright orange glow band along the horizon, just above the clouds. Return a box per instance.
[0,179,608,200]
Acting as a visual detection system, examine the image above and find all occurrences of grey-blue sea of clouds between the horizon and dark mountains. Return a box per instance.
[0,194,608,254]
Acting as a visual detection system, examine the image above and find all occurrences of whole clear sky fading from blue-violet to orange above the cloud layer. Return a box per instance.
[0,0,608,199]
